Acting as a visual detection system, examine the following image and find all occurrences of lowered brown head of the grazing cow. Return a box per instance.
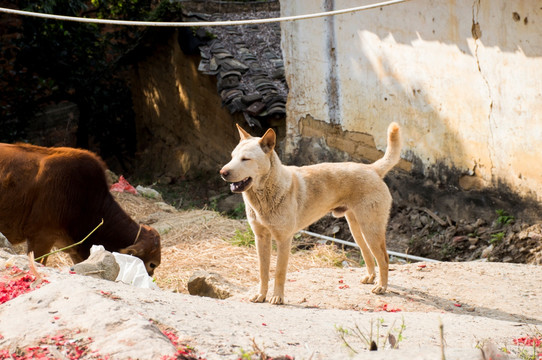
[119,225,162,276]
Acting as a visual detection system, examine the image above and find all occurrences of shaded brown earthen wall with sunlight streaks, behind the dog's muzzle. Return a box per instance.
[128,31,242,183]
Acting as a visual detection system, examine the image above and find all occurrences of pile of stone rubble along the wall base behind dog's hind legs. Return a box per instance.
[309,207,542,265]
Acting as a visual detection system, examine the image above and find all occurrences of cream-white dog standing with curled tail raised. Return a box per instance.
[220,123,401,304]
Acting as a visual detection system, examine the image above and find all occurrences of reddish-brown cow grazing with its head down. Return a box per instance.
[0,144,161,275]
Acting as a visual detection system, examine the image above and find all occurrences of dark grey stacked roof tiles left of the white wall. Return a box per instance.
[196,12,288,127]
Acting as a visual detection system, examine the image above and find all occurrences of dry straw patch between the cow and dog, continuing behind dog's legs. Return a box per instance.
[13,193,349,293]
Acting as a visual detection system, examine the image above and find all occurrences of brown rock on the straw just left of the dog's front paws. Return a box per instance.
[187,270,245,299]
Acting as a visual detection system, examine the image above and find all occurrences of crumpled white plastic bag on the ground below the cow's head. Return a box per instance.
[90,245,158,289]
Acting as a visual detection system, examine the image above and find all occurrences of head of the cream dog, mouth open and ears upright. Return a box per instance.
[220,125,277,193]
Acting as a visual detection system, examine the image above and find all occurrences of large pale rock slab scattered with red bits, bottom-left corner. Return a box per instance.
[0,272,175,360]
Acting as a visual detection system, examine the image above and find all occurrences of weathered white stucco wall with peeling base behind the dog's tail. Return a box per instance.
[281,0,542,201]
